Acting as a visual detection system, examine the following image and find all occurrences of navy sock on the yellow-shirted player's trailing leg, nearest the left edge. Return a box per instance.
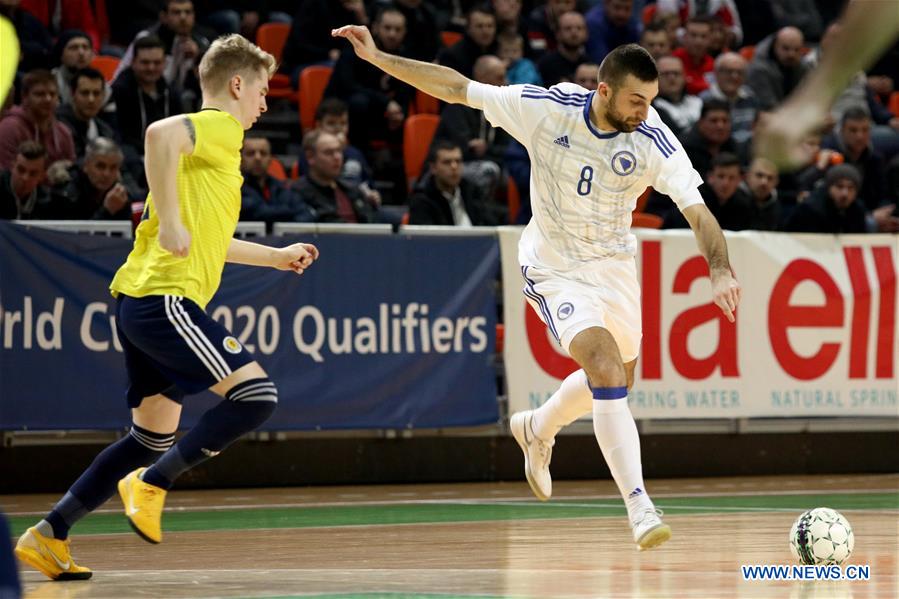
[38,425,175,539]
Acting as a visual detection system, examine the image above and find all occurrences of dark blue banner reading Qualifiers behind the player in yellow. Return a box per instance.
[0,223,499,430]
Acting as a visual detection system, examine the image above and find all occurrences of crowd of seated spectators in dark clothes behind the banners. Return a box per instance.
[0,0,899,233]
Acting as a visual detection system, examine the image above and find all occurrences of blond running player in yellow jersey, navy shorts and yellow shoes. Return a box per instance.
[15,35,318,580]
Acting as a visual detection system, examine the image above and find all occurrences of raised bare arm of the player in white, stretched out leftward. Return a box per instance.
[331,25,471,104]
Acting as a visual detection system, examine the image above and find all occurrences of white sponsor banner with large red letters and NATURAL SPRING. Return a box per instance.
[500,227,899,418]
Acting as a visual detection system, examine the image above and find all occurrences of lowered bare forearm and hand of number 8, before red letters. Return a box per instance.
[684,204,742,322]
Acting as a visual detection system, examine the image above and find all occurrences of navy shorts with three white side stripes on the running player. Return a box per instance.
[116,295,253,408]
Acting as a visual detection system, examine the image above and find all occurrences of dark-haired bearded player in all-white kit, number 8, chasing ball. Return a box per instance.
[333,25,740,550]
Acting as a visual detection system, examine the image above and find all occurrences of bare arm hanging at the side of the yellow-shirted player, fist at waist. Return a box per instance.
[144,116,196,257]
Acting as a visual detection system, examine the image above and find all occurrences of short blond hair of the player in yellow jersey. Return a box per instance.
[199,33,278,94]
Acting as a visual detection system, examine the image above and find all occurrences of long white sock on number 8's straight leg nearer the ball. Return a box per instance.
[593,397,653,521]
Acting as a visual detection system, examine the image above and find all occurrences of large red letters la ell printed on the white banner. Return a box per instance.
[525,241,897,380]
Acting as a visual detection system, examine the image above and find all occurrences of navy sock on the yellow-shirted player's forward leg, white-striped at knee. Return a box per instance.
[142,378,278,489]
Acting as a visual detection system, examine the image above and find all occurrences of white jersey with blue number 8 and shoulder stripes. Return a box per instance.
[468,83,703,270]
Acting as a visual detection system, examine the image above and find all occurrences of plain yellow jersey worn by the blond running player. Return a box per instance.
[110,109,243,310]
